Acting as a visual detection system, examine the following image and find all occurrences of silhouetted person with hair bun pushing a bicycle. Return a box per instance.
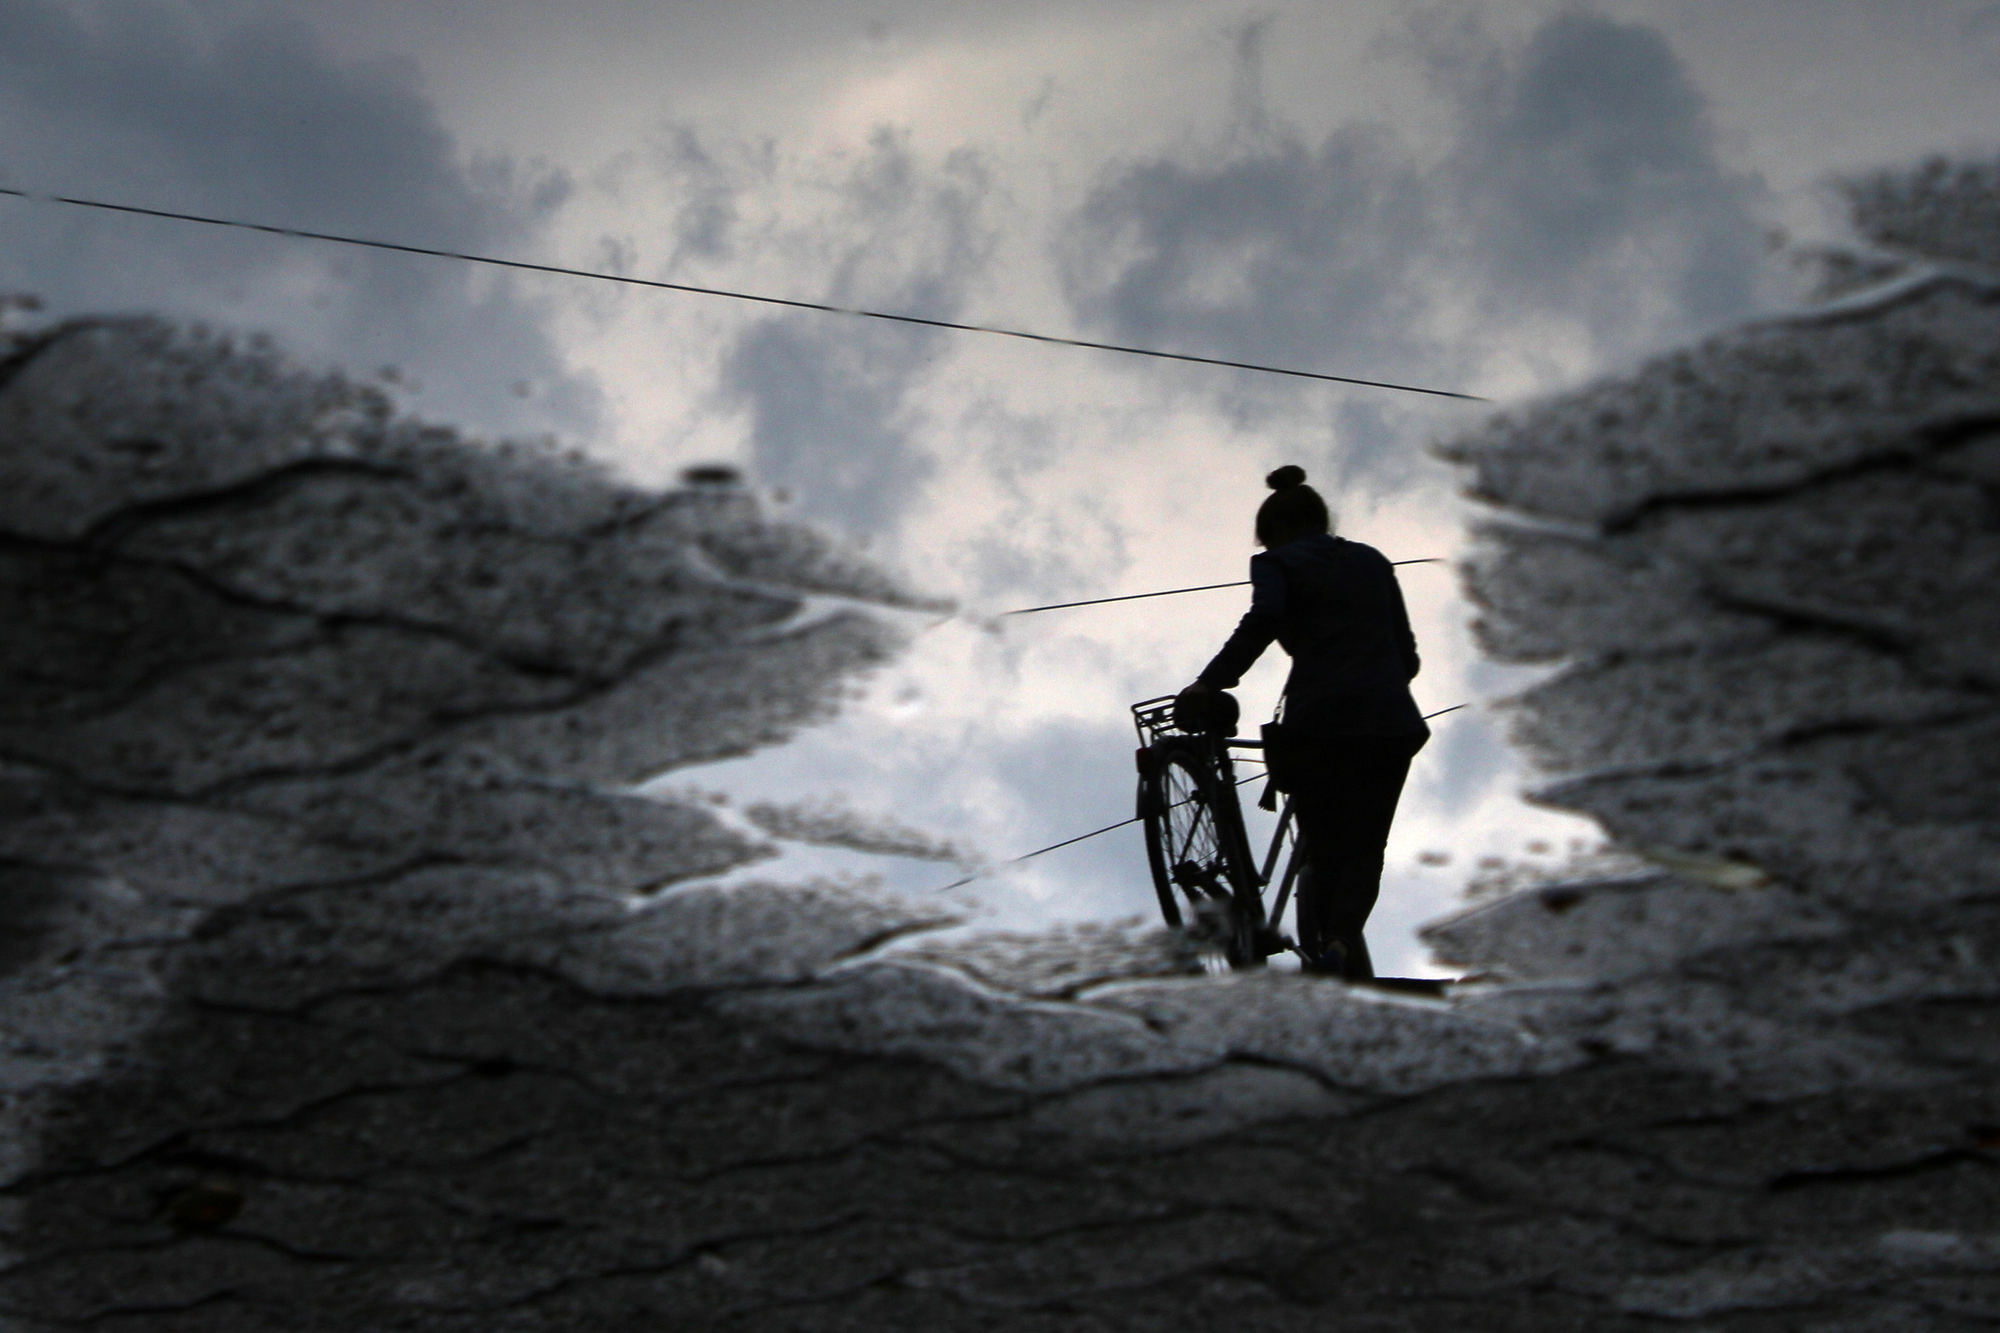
[1176,466,1430,979]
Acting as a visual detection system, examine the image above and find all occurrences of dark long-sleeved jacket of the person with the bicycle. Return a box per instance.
[1198,532,1430,737]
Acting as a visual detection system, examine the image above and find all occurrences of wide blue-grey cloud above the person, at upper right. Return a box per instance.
[1062,14,1758,420]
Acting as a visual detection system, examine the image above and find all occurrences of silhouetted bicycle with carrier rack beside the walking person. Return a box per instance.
[1132,695,1306,969]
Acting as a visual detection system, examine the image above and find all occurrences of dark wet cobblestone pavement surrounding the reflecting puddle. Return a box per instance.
[11,168,2000,1333]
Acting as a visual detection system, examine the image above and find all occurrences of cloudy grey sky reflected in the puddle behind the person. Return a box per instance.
[0,0,2000,967]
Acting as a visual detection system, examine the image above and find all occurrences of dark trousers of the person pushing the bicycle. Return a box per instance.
[1292,737,1426,979]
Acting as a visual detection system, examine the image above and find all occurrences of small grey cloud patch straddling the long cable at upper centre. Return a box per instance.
[716,130,992,532]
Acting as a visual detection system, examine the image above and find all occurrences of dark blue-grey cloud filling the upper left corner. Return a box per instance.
[0,0,594,428]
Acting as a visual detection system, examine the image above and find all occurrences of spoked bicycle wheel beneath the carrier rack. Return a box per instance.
[1138,741,1264,967]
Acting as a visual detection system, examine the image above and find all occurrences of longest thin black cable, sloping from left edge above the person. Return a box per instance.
[0,186,1488,402]
